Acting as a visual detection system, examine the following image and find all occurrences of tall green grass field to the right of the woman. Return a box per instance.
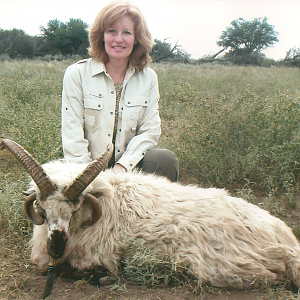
[157,66,300,195]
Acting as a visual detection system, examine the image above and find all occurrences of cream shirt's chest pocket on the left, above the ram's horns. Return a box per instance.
[83,94,103,132]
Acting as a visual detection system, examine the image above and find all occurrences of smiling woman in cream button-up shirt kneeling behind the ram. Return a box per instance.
[62,1,178,181]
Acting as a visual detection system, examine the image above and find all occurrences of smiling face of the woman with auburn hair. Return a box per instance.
[104,16,135,61]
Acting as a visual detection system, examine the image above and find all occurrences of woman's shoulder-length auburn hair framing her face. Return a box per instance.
[89,1,154,71]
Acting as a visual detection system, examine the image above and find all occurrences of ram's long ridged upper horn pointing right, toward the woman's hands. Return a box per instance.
[63,144,114,202]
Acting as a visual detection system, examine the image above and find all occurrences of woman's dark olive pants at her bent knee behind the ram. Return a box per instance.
[137,149,179,182]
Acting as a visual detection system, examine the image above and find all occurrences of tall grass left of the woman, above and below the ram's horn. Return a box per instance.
[0,60,70,239]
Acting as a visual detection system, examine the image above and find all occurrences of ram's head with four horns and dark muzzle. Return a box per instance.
[0,137,113,298]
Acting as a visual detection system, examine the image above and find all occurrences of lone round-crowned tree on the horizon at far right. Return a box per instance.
[217,17,278,64]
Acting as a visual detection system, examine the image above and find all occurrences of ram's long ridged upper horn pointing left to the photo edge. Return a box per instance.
[0,137,56,198]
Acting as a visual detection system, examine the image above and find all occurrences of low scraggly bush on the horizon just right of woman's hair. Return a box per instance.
[150,38,190,63]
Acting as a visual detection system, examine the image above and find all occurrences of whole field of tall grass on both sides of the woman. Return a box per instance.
[0,60,300,237]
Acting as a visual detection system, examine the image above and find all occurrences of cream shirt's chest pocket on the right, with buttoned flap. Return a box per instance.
[124,95,149,122]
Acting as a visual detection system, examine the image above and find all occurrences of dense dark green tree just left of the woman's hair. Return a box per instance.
[40,19,89,55]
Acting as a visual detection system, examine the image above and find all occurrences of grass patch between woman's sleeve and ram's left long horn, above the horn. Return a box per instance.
[0,61,68,163]
